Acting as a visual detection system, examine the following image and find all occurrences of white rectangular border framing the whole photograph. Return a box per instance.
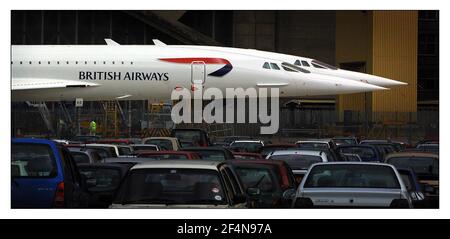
[0,0,450,219]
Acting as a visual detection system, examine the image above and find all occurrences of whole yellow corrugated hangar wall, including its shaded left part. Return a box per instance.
[336,11,418,122]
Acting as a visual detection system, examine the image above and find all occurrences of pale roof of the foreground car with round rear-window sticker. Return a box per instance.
[131,160,223,171]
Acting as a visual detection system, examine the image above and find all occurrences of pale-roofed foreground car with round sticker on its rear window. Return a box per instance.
[111,160,248,208]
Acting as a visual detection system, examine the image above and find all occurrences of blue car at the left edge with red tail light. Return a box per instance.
[11,138,88,208]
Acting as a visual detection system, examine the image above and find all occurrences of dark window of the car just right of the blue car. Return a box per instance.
[78,167,121,191]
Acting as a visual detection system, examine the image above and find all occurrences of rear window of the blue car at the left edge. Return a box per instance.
[11,143,57,178]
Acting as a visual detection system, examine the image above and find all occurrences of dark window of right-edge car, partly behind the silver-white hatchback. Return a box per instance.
[387,157,439,178]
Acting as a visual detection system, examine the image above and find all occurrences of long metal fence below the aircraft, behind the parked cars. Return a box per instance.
[11,101,439,142]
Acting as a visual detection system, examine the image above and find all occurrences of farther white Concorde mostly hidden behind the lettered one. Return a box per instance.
[158,39,407,87]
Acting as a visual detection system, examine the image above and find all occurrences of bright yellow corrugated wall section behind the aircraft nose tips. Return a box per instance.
[372,11,418,116]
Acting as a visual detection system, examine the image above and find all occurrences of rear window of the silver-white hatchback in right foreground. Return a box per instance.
[304,164,400,189]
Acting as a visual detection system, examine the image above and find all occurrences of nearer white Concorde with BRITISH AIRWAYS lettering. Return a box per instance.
[11,39,385,101]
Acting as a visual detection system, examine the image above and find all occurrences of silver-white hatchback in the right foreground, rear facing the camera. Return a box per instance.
[293,162,412,208]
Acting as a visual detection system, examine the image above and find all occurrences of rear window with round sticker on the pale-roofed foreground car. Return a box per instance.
[124,168,227,205]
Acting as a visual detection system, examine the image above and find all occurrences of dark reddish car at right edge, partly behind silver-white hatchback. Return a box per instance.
[385,152,439,204]
